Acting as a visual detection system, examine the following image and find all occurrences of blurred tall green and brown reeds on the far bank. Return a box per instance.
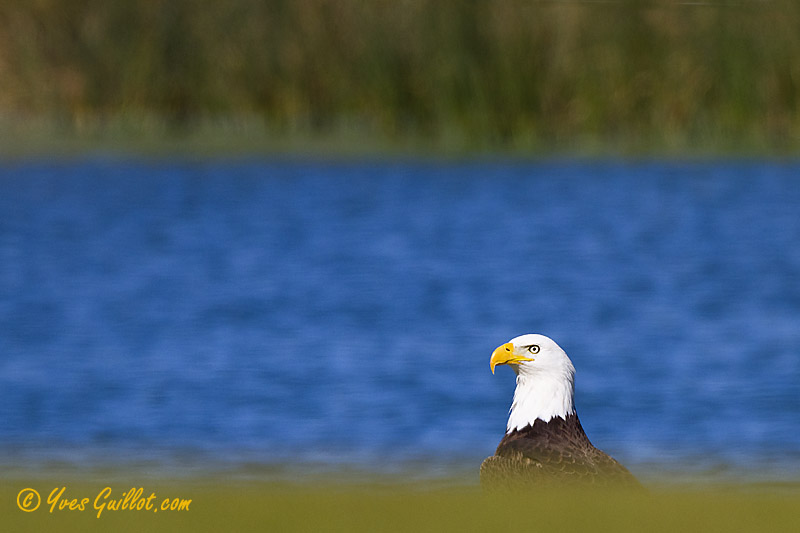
[0,0,800,153]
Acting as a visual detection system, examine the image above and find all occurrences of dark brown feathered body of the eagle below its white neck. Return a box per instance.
[481,414,639,489]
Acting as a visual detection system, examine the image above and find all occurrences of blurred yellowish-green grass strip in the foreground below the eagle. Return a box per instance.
[0,479,800,533]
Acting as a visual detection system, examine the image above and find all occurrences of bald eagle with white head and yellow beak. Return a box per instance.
[480,334,639,489]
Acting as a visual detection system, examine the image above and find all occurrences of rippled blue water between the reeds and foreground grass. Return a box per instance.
[0,159,800,479]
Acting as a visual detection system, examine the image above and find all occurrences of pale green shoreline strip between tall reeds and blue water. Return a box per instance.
[0,114,800,161]
